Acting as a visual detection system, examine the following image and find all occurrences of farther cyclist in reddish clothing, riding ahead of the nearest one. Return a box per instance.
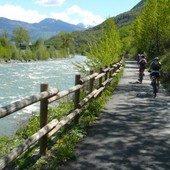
[138,54,147,83]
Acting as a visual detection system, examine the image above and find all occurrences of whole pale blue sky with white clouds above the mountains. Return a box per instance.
[0,0,141,26]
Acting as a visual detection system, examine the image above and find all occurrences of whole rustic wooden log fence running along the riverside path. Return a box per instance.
[0,59,123,169]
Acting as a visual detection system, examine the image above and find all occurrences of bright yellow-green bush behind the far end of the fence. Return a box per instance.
[86,18,121,70]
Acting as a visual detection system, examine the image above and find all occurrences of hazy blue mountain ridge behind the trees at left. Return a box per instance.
[0,17,85,40]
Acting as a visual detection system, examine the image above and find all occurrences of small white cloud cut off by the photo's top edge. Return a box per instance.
[36,0,65,6]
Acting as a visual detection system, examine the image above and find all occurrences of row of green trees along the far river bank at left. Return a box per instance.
[0,27,74,61]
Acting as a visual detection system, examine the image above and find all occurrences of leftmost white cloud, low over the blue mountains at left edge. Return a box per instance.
[0,4,48,23]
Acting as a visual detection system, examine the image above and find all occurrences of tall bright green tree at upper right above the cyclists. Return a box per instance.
[134,0,170,58]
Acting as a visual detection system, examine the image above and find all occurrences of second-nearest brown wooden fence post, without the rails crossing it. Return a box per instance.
[74,74,80,124]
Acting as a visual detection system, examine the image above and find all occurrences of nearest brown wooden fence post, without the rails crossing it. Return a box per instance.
[40,84,48,155]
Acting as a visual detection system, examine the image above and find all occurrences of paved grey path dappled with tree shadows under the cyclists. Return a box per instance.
[59,61,170,170]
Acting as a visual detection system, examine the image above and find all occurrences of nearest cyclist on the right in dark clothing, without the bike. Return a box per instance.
[149,57,161,88]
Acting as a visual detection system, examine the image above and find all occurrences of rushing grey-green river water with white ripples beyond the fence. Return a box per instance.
[0,55,86,136]
